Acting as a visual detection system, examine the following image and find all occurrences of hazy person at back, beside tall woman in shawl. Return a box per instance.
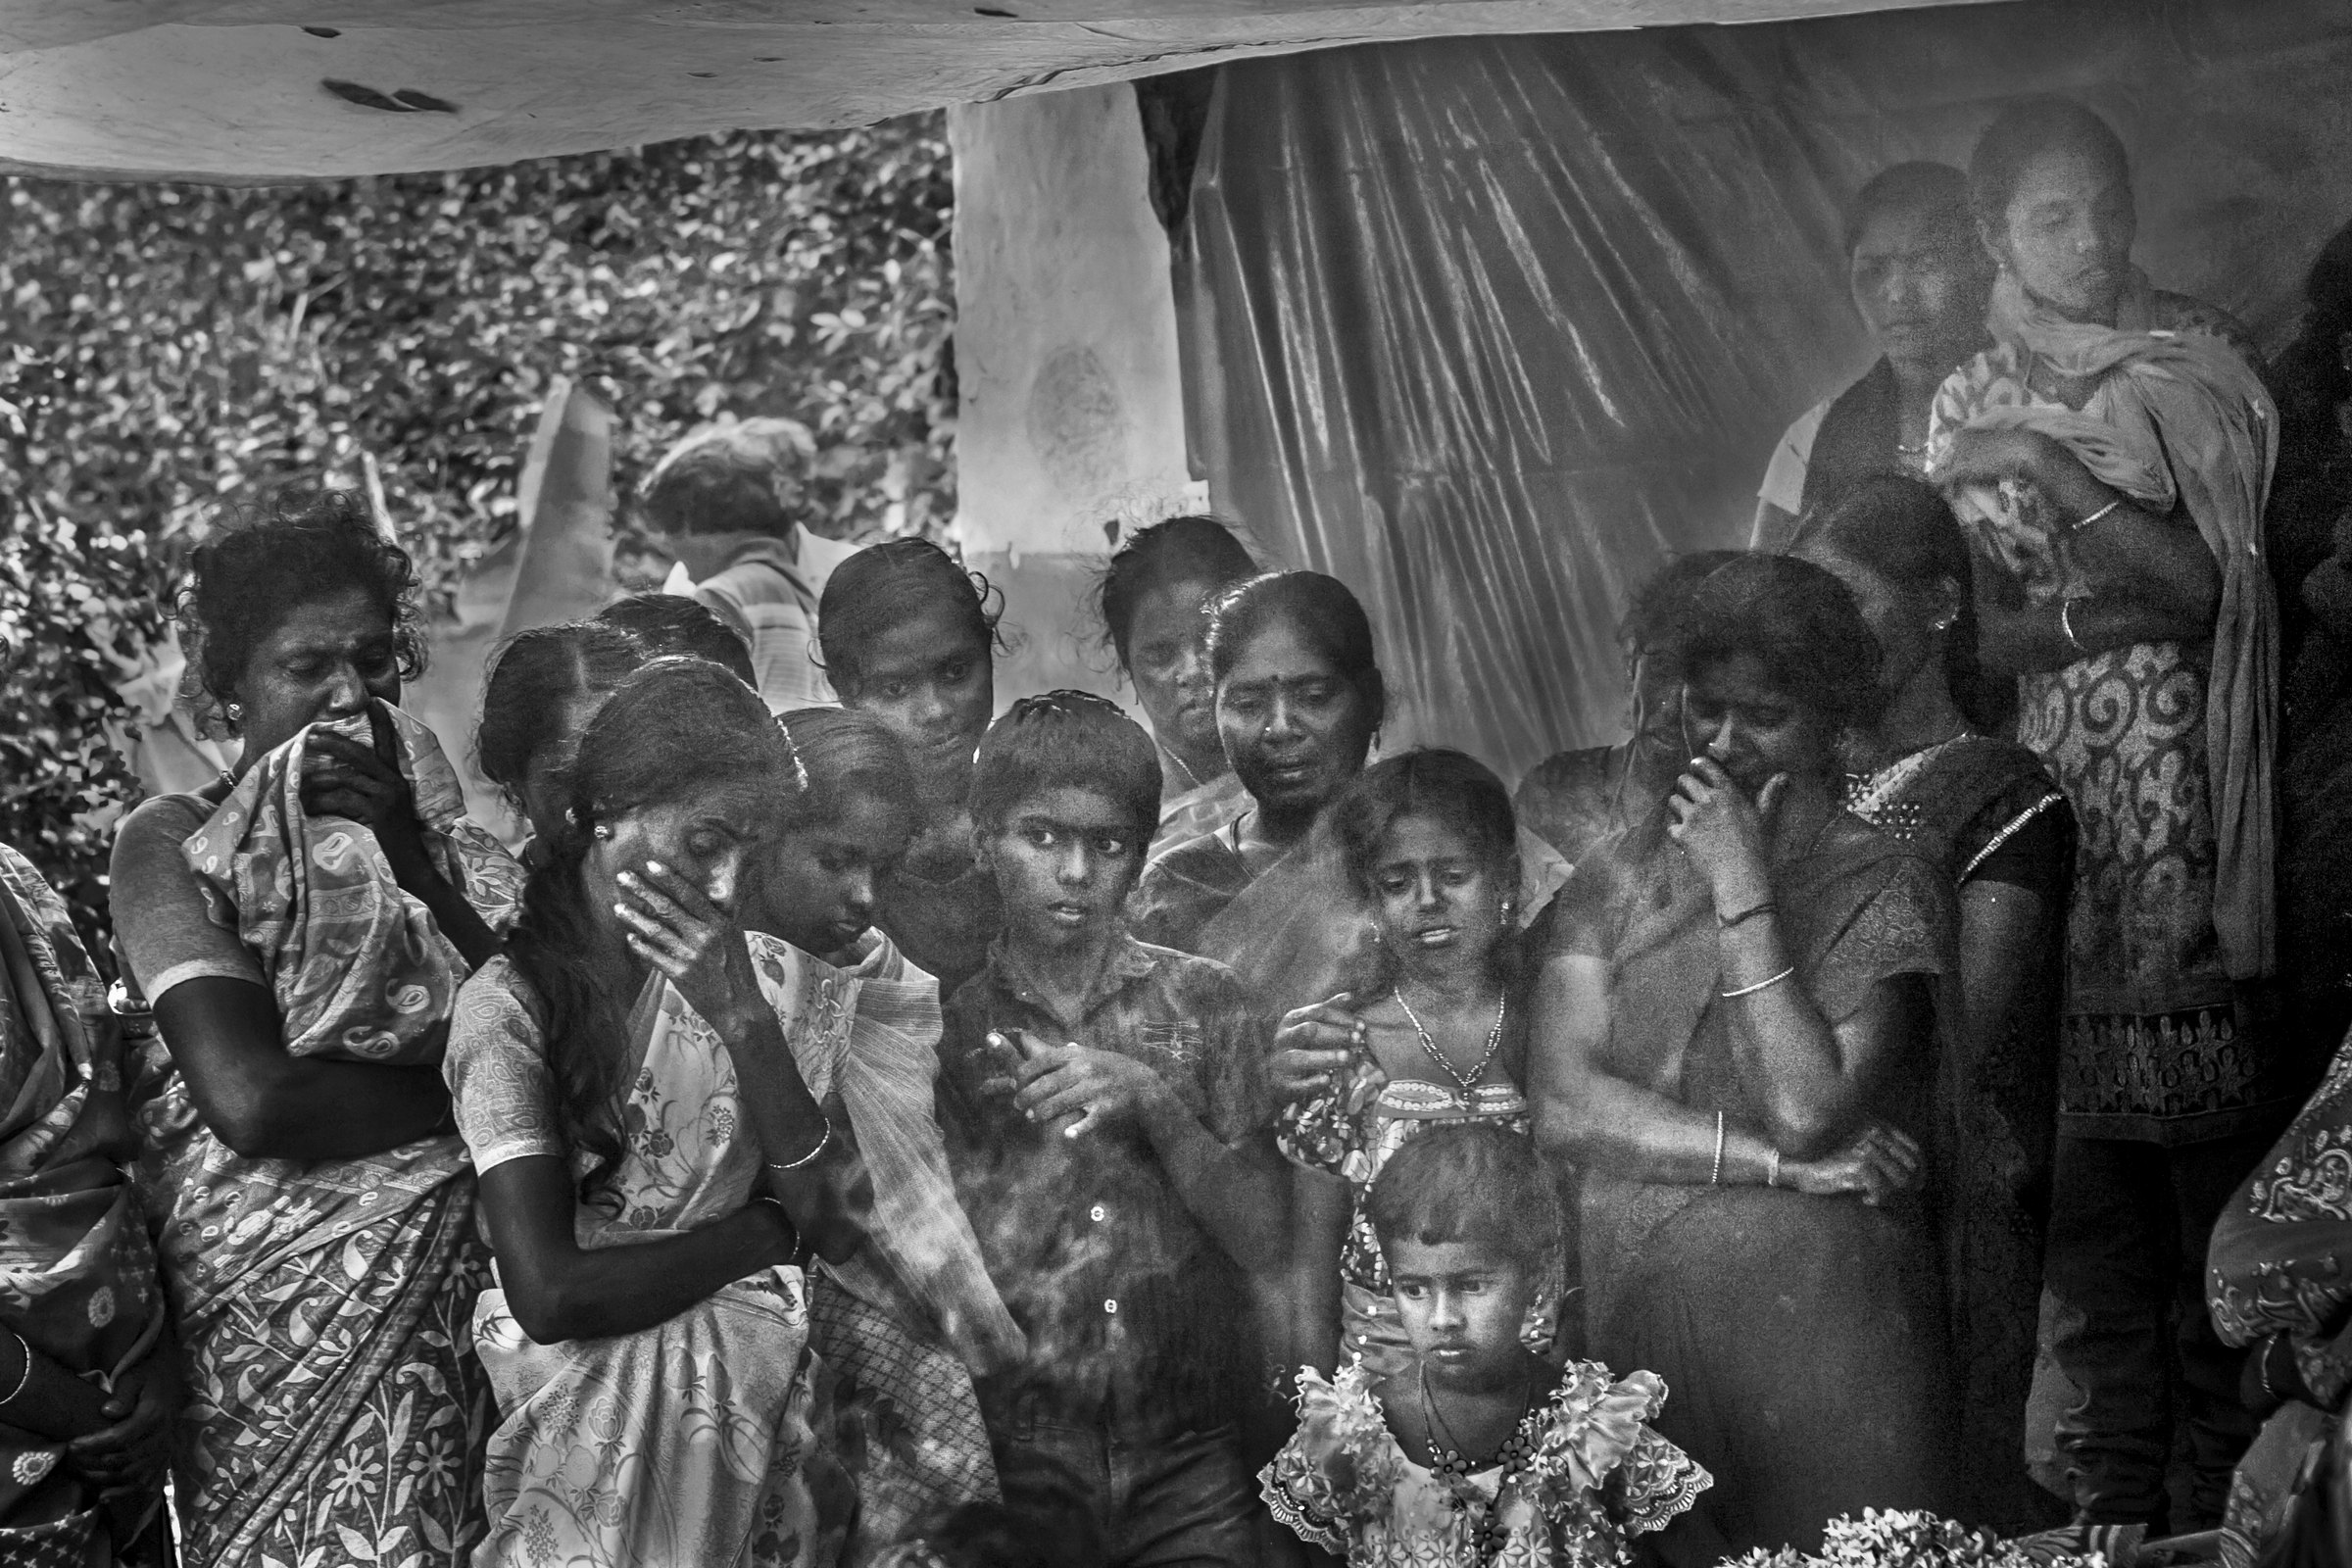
[1750,163,1992,550]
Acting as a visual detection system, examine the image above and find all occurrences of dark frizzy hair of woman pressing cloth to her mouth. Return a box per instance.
[174,489,425,729]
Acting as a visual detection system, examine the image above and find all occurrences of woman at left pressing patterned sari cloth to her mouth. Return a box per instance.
[113,496,519,1566]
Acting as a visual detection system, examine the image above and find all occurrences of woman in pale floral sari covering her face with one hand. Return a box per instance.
[447,659,858,1568]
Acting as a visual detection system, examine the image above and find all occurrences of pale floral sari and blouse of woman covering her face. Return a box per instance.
[449,959,854,1568]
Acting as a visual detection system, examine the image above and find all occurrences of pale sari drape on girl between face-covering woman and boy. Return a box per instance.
[751,931,1028,1563]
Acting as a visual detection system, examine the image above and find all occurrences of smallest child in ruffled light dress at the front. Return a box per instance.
[1260,1124,1710,1568]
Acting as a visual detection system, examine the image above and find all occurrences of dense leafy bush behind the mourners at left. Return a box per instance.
[0,116,955,958]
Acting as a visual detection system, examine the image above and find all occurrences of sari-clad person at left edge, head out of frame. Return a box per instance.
[0,844,178,1568]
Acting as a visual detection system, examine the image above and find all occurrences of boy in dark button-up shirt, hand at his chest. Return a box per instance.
[939,691,1284,1566]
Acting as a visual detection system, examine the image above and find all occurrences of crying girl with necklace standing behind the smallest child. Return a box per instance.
[1272,750,1559,1373]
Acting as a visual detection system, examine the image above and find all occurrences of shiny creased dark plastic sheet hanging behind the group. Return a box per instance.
[1176,0,2352,778]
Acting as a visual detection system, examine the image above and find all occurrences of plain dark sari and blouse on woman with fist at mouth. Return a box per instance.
[1559,811,1957,1549]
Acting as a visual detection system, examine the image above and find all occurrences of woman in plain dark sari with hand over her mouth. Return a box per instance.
[1529,555,1954,1561]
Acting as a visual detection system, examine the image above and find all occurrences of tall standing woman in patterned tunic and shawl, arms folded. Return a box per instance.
[1931,99,2277,1528]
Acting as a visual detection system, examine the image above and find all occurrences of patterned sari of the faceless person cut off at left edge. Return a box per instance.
[0,844,165,1568]
